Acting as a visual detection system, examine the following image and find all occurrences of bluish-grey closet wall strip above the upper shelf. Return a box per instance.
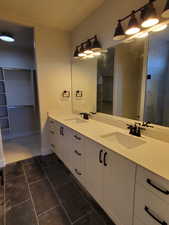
[0,42,35,69]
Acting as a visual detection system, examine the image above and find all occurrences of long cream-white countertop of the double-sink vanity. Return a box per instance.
[48,112,169,180]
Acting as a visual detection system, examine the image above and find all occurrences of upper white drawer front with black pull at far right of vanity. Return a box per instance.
[136,167,169,204]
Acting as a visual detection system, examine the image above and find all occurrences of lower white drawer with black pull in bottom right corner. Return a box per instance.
[134,184,169,225]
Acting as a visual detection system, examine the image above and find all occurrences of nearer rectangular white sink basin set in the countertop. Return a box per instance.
[101,132,146,149]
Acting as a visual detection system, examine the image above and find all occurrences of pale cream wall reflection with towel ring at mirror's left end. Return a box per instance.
[72,58,97,113]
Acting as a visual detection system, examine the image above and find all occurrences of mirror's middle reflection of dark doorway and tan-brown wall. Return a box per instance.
[97,40,145,120]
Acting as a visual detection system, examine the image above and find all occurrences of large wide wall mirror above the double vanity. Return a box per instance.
[72,25,169,126]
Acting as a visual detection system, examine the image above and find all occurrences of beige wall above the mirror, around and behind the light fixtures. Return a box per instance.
[72,0,166,48]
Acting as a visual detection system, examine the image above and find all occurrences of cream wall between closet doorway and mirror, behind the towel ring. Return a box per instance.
[35,27,72,154]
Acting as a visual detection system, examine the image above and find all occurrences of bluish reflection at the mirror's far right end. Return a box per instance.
[144,28,169,126]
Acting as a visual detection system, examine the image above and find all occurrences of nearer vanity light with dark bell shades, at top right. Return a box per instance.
[113,0,169,41]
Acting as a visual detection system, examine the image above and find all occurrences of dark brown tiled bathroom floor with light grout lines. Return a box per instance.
[0,154,114,225]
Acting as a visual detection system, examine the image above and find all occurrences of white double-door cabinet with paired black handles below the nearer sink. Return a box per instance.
[85,140,136,225]
